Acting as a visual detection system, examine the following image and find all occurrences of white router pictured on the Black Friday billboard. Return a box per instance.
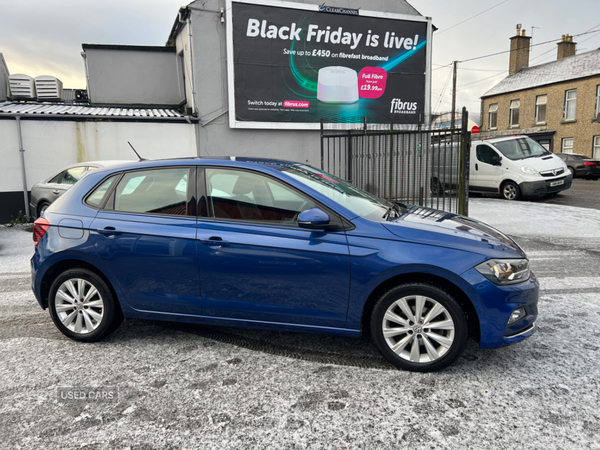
[317,66,358,103]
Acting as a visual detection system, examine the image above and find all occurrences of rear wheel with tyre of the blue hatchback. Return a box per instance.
[48,268,123,342]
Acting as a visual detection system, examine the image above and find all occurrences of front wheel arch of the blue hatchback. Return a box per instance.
[360,272,481,342]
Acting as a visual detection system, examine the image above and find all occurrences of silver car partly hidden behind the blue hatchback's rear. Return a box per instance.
[29,161,132,218]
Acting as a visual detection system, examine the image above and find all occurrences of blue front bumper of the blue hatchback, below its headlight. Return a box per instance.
[462,269,540,348]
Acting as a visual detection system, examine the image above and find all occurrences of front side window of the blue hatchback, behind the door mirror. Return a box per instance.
[205,168,315,226]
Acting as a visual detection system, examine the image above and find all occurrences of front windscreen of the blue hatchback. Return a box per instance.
[281,164,392,221]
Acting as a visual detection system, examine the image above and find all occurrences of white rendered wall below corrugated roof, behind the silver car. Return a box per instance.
[0,119,196,192]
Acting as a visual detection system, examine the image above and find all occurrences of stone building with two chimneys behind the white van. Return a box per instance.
[481,30,600,158]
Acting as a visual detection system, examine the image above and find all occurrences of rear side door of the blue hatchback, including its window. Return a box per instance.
[86,166,201,315]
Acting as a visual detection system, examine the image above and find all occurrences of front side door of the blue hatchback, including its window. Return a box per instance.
[197,167,350,327]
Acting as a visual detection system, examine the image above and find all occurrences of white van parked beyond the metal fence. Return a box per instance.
[469,136,573,200]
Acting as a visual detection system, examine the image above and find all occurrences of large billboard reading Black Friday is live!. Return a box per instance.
[227,0,430,129]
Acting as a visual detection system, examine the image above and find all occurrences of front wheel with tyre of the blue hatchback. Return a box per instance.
[371,283,469,372]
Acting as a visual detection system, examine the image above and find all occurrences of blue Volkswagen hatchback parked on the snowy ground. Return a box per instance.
[31,157,539,372]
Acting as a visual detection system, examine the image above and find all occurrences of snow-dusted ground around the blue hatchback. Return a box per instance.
[0,199,600,450]
